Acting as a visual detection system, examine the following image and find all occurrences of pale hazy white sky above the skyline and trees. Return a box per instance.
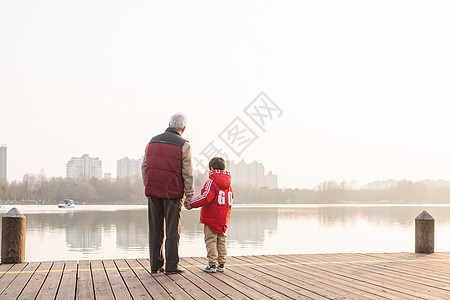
[0,0,450,188]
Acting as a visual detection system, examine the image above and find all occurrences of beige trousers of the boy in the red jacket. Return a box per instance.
[204,224,227,266]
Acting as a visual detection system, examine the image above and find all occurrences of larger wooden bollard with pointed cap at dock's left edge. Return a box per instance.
[2,207,27,264]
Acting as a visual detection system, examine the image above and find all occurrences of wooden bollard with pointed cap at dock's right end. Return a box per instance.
[415,211,434,253]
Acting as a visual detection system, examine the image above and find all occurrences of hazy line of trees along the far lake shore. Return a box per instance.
[0,176,450,204]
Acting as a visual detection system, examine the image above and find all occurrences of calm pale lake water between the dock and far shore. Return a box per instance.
[0,204,450,261]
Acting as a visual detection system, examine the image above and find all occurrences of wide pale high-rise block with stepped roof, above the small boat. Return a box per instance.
[66,154,102,181]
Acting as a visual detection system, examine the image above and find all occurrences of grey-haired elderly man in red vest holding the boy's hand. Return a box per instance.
[142,113,194,275]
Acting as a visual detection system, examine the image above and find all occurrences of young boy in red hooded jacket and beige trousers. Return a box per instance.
[187,157,233,273]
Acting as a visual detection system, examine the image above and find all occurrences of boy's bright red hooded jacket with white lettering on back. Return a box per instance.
[191,170,234,233]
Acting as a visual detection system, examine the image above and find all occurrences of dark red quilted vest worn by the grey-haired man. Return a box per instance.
[145,128,186,199]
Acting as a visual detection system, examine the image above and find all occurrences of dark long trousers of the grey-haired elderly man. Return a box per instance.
[148,197,182,271]
